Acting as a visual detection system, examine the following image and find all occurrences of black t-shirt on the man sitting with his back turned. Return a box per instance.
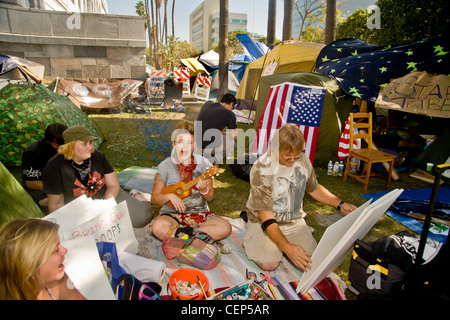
[196,101,237,149]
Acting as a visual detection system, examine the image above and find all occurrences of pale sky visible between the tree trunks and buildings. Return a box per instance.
[106,0,376,42]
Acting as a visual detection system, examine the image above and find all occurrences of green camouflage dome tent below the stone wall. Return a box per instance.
[0,83,104,166]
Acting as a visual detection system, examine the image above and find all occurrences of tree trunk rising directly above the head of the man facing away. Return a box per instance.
[217,0,229,101]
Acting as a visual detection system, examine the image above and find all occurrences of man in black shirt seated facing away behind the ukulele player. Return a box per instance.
[195,93,237,163]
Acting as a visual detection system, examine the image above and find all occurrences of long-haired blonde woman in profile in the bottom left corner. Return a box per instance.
[0,219,85,300]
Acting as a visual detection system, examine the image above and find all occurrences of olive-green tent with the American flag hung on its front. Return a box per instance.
[255,72,354,167]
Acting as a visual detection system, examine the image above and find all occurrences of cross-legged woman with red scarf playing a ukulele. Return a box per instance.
[151,120,231,241]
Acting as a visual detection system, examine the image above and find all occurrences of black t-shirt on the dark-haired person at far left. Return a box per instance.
[22,138,56,185]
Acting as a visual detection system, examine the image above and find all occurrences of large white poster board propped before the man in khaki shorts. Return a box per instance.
[297,189,403,294]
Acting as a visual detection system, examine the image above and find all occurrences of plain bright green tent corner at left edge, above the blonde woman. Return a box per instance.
[0,162,44,225]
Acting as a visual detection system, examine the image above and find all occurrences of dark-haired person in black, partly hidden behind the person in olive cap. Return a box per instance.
[22,123,67,209]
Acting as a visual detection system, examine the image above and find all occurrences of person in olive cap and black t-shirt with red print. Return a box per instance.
[43,126,153,228]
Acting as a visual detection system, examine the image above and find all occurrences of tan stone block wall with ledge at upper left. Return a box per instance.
[0,7,146,80]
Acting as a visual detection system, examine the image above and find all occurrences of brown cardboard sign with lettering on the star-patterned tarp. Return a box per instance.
[375,71,450,118]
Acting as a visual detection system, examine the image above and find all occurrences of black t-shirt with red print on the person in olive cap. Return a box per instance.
[44,150,114,204]
